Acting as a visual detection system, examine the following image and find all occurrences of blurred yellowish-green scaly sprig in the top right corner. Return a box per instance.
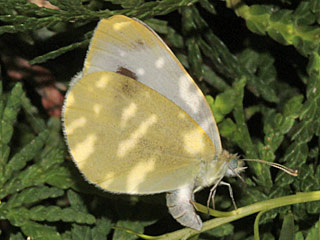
[228,1,320,56]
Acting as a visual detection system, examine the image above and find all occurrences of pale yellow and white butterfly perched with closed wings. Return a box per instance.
[63,15,298,230]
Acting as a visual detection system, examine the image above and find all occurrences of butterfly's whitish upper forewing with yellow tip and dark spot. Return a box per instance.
[83,15,222,153]
